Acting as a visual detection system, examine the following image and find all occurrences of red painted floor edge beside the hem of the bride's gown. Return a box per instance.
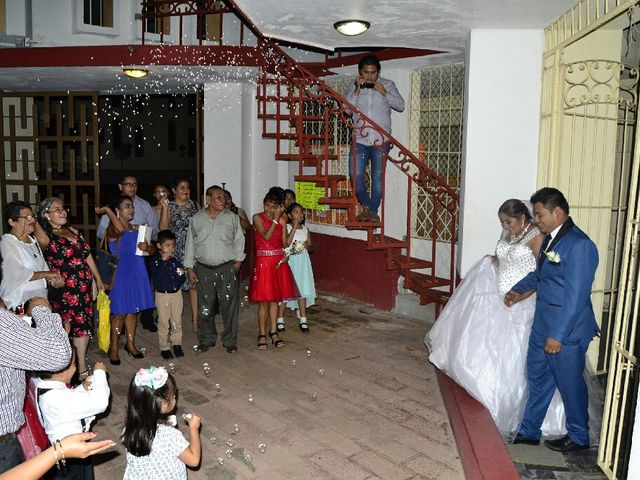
[436,370,520,480]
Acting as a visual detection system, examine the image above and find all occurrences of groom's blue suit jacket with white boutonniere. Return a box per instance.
[512,218,599,343]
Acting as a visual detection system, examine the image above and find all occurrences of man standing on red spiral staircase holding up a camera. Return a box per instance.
[346,55,404,222]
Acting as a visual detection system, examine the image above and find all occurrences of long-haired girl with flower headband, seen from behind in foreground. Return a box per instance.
[122,366,201,480]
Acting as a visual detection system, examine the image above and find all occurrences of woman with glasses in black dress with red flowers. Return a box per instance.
[35,197,104,380]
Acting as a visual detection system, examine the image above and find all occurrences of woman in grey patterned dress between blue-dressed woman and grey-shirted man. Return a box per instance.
[160,178,200,331]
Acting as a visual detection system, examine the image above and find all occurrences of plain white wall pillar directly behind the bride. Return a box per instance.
[458,30,543,276]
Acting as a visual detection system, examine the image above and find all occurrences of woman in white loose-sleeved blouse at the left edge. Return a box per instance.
[0,201,63,313]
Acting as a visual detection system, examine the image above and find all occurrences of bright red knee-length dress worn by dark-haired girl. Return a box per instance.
[249,212,299,302]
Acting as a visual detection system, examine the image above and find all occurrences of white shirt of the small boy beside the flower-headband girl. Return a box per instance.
[35,370,109,443]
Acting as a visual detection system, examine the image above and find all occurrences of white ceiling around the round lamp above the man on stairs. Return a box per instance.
[236,0,576,52]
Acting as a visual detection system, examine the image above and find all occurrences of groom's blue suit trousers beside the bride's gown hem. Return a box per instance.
[520,331,591,445]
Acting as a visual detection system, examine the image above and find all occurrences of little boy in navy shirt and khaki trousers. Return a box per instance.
[150,230,186,360]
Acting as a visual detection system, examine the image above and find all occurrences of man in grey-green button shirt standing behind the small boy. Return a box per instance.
[183,185,245,353]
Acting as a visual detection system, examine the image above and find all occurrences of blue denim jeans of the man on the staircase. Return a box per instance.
[349,143,389,213]
